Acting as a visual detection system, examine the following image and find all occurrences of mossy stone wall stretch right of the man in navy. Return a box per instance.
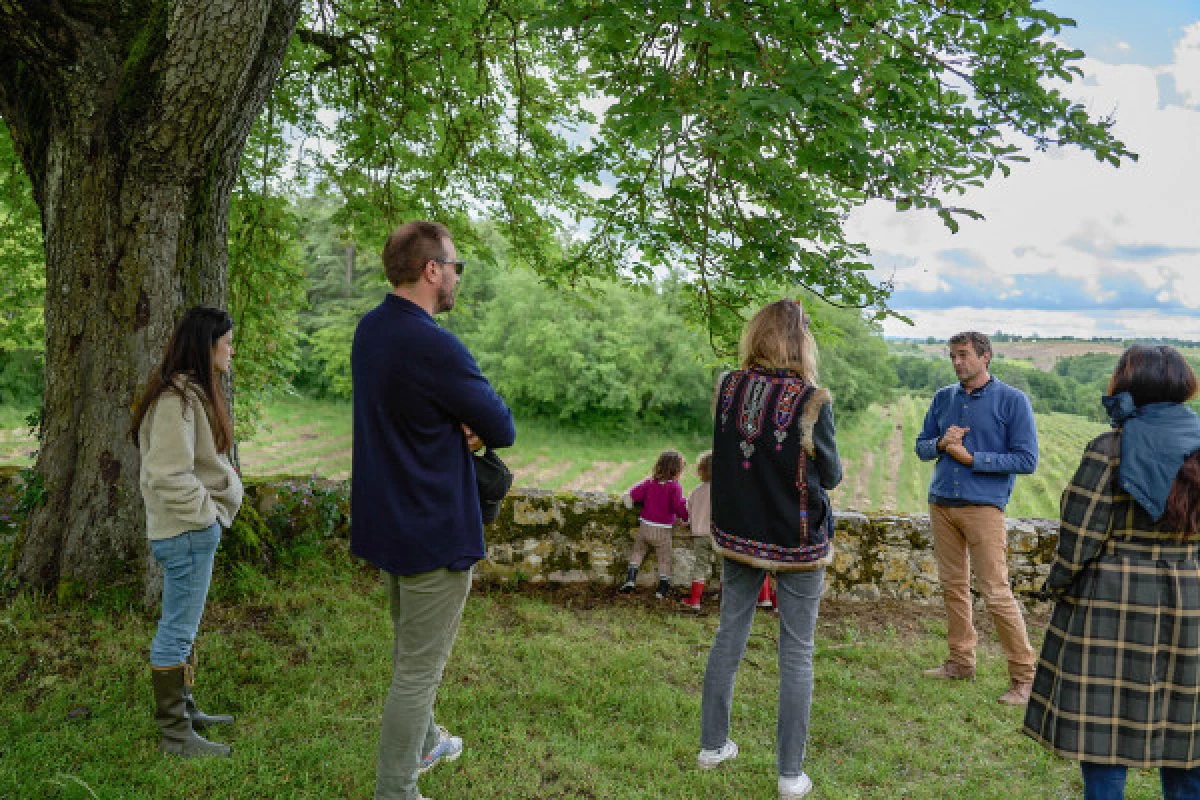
[478,489,1057,602]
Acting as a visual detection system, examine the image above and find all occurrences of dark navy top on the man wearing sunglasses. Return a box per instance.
[350,294,516,575]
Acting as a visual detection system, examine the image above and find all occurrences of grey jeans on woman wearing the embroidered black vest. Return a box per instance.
[700,559,824,777]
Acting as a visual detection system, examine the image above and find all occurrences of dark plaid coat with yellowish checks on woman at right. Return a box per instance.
[1024,432,1200,768]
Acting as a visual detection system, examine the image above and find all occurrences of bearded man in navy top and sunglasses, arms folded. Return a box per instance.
[350,222,516,800]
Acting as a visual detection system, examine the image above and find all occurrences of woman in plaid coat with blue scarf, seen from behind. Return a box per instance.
[1024,345,1200,800]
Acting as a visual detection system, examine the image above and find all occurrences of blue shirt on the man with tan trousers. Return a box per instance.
[916,378,1038,511]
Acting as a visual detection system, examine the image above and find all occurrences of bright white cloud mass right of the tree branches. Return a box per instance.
[847,20,1200,338]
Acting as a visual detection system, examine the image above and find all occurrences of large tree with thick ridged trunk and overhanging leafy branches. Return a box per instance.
[0,0,1129,599]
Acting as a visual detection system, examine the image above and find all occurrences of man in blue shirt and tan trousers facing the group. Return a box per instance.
[917,331,1038,705]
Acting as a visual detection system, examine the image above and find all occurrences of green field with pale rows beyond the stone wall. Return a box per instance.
[0,396,1105,517]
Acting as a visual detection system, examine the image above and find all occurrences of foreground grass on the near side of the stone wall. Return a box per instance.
[0,541,1158,800]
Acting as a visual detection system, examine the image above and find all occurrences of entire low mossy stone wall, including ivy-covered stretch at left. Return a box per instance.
[0,468,1057,602]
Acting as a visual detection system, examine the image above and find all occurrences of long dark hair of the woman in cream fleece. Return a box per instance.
[130,306,233,453]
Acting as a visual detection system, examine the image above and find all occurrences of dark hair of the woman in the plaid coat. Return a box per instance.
[1109,344,1200,536]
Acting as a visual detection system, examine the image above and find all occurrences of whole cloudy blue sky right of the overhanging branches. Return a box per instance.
[848,0,1200,341]
